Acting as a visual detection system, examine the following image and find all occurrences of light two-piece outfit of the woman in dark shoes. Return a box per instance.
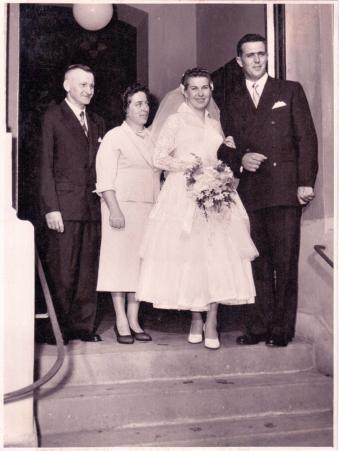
[96,122,160,292]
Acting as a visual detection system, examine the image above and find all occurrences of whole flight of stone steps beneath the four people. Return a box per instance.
[36,323,333,447]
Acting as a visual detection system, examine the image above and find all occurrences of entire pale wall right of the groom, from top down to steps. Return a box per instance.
[286,4,334,371]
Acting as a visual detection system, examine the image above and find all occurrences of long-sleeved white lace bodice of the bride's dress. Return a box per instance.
[154,104,223,172]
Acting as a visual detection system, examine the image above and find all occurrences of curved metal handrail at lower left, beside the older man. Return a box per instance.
[4,251,65,404]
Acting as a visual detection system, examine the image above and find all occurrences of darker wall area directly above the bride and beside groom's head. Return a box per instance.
[197,3,266,72]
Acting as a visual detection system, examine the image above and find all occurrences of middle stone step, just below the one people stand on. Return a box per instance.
[37,371,333,435]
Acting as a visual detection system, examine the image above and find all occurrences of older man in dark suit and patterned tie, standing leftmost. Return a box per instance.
[39,65,104,344]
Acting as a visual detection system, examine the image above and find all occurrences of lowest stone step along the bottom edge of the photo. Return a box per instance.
[40,411,333,448]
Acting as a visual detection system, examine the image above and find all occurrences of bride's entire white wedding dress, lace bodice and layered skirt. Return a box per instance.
[136,103,258,311]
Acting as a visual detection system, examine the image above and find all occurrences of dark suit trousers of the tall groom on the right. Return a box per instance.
[246,206,301,339]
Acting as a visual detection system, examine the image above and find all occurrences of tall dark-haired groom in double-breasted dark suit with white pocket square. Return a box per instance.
[219,34,318,346]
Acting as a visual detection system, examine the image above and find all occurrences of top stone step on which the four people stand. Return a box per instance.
[36,331,313,387]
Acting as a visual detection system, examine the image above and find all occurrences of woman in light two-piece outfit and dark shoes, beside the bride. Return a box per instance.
[96,85,160,344]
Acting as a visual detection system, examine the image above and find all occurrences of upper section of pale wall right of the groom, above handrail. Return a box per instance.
[286,5,334,219]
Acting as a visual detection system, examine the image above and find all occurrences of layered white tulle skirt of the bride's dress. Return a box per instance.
[136,173,258,311]
